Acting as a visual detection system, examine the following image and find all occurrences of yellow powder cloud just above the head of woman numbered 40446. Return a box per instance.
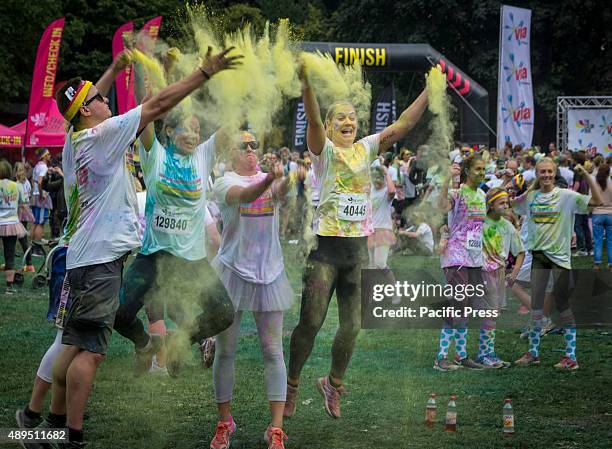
[300,52,372,129]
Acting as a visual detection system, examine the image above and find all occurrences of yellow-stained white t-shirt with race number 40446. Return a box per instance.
[310,134,380,237]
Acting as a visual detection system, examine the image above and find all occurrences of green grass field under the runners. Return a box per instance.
[0,247,612,449]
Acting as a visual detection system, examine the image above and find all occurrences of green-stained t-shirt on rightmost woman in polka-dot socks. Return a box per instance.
[514,187,591,269]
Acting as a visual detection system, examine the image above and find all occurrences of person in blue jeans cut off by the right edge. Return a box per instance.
[593,162,612,271]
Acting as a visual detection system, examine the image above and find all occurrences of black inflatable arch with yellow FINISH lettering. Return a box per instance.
[302,42,489,144]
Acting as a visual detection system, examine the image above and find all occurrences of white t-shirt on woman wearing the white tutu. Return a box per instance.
[213,172,285,284]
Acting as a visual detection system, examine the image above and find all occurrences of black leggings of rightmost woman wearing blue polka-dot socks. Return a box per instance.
[531,251,574,313]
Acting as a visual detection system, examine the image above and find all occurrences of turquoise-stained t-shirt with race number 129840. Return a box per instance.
[140,134,215,260]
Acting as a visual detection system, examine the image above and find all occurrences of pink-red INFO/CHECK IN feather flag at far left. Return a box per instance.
[25,17,66,147]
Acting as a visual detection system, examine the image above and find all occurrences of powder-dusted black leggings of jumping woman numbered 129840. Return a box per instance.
[114,251,234,348]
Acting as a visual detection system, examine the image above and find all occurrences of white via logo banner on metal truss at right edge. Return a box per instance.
[567,108,612,156]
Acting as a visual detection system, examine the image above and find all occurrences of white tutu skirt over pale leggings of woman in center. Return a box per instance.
[211,258,295,312]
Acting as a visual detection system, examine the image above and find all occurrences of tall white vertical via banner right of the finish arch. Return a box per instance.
[497,5,534,148]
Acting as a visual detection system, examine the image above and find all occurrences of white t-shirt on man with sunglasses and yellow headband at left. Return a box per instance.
[64,106,141,269]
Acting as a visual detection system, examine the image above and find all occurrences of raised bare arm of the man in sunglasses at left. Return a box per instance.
[138,47,242,130]
